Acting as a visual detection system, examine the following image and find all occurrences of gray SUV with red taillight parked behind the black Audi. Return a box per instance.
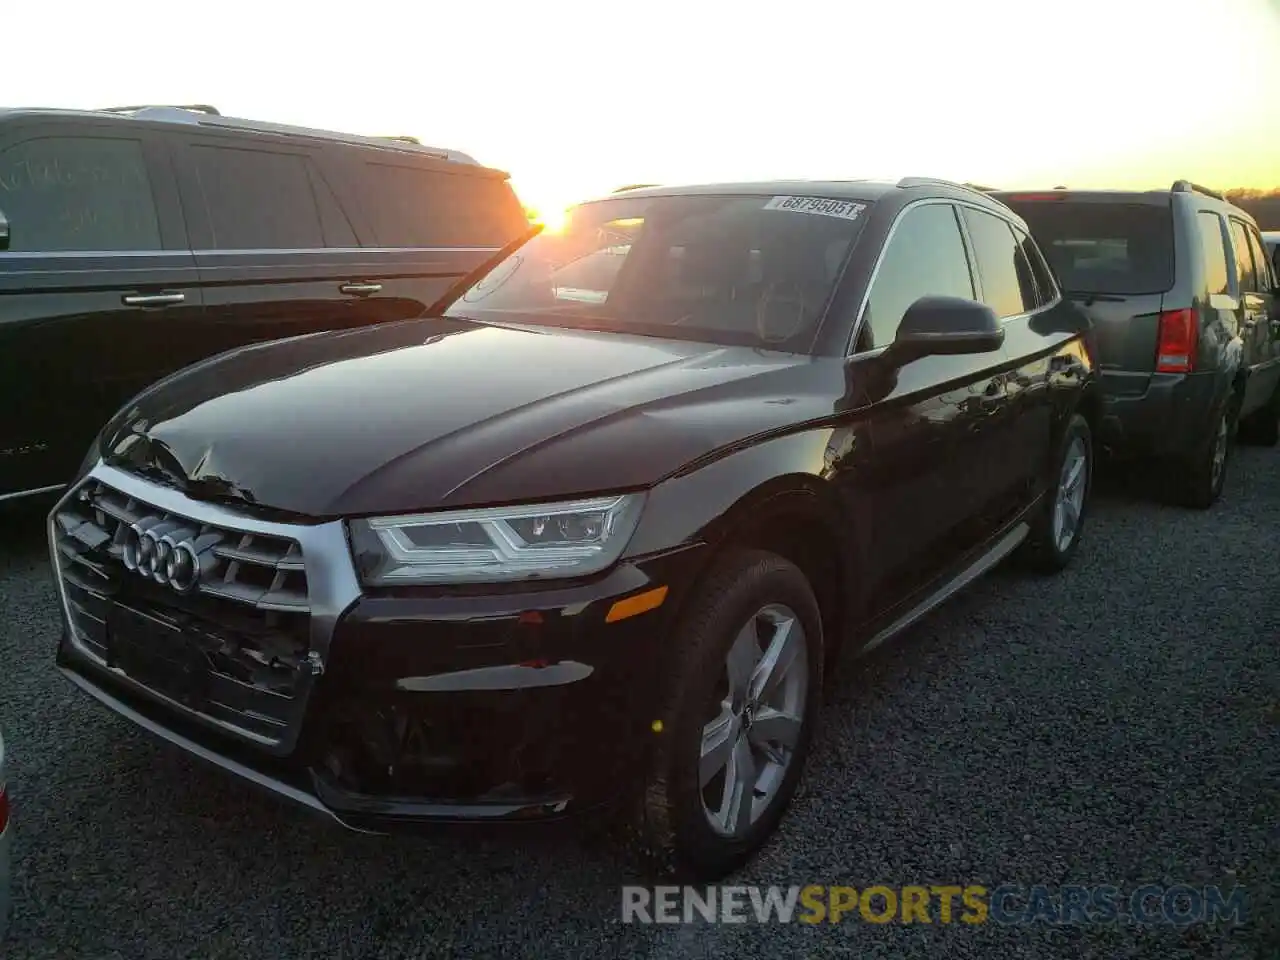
[993,180,1280,508]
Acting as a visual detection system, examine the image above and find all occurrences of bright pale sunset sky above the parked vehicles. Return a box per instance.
[10,0,1280,217]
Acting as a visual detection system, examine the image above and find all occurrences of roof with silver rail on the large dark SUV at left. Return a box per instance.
[0,104,494,166]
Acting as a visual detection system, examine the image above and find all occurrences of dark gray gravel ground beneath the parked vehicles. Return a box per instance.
[0,449,1280,960]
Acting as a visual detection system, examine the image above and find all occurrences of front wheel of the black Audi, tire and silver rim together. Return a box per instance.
[644,550,823,881]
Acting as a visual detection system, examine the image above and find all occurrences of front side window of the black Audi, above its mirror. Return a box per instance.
[858,204,974,351]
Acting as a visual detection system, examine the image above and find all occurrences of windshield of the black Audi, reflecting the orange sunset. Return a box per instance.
[447,196,865,351]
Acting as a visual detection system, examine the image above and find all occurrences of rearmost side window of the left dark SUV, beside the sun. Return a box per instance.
[364,163,527,247]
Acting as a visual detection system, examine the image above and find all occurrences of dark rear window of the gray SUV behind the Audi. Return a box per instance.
[1005,197,1174,296]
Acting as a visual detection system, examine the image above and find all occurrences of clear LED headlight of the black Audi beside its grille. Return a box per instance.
[349,494,644,586]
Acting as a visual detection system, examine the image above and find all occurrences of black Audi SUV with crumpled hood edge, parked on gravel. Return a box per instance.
[49,178,1100,877]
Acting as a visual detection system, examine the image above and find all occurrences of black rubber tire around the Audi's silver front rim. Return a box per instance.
[641,550,823,881]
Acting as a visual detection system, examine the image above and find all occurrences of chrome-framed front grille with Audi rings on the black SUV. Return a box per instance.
[49,463,360,755]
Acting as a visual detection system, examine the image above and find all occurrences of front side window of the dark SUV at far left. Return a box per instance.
[0,137,160,251]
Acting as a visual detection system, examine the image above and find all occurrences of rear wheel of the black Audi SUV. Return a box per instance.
[1023,413,1093,573]
